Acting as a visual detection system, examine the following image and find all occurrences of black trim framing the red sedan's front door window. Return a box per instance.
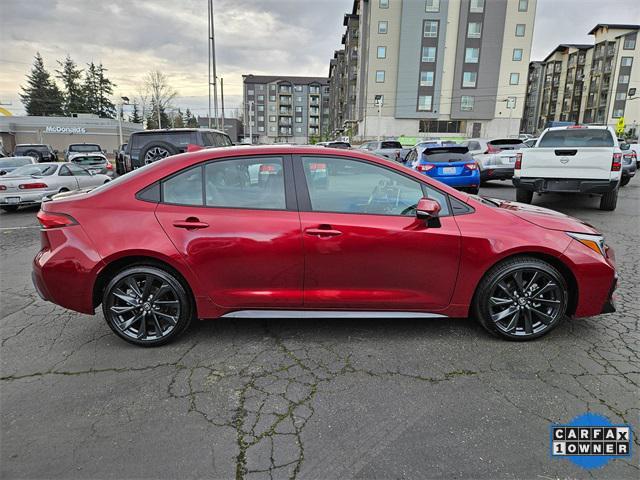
[291,153,453,218]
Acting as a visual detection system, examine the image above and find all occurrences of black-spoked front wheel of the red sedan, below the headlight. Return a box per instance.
[473,256,569,341]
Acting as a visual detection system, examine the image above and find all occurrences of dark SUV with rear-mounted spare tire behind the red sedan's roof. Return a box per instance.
[124,128,233,172]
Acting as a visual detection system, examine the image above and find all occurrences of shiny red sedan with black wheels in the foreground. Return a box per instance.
[33,146,617,346]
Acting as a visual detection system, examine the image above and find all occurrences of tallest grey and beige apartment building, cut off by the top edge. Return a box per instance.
[330,0,536,140]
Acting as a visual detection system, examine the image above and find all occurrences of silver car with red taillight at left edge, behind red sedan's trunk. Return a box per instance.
[0,162,110,212]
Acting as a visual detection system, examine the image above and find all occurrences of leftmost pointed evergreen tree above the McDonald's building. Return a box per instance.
[20,52,63,116]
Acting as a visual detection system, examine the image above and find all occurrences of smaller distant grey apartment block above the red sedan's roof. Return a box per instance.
[242,75,330,144]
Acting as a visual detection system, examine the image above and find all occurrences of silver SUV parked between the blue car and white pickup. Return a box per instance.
[462,138,527,182]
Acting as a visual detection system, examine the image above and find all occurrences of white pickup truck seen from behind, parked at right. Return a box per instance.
[513,125,622,210]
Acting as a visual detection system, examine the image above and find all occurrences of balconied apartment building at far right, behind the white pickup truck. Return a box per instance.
[526,24,640,133]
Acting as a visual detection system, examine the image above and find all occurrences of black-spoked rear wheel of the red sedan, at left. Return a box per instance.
[102,265,194,347]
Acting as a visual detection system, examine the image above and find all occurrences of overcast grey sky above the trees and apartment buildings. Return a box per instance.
[0,0,640,115]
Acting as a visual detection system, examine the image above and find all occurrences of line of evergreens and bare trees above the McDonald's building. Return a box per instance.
[20,52,198,129]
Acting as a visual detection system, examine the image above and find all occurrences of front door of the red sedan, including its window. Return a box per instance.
[294,155,460,311]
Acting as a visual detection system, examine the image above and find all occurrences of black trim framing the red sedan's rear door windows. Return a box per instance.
[160,154,298,212]
